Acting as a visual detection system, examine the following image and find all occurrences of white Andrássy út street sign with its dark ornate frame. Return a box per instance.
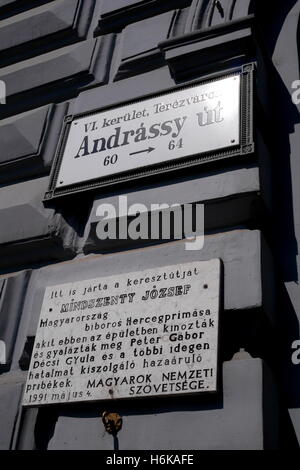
[45,64,252,199]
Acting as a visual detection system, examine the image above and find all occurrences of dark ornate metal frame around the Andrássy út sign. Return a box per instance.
[44,63,255,202]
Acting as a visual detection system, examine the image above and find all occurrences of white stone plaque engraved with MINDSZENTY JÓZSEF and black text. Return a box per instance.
[23,259,220,406]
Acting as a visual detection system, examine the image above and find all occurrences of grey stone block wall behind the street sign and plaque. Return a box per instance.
[0,0,300,450]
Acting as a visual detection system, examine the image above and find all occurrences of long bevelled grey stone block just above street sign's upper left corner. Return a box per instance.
[0,35,113,118]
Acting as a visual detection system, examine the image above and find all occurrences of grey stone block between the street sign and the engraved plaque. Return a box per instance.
[84,165,260,252]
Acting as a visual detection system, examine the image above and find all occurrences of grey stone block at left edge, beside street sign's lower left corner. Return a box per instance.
[0,177,75,268]
